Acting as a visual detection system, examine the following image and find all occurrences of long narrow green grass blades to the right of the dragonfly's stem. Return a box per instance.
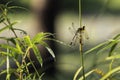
[74,34,120,80]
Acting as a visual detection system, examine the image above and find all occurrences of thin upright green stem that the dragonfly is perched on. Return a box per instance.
[79,0,85,80]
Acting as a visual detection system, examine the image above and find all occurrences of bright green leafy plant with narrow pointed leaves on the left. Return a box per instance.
[0,3,55,80]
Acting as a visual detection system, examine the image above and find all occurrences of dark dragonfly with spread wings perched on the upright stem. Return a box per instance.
[69,23,89,45]
